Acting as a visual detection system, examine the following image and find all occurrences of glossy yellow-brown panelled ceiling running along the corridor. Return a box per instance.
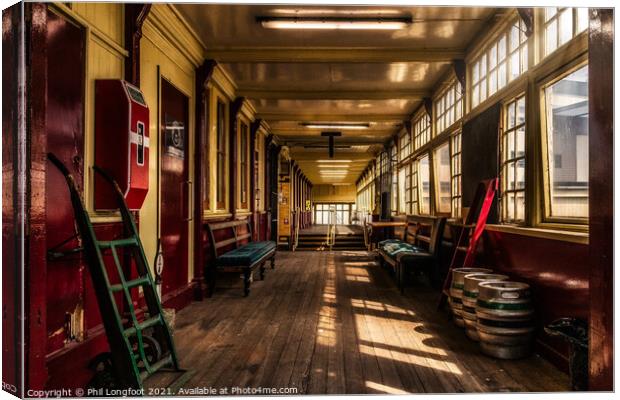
[175,4,496,184]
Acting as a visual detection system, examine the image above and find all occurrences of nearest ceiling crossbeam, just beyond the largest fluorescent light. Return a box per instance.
[206,47,465,63]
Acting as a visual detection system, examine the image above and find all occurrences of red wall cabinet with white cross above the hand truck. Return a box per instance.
[95,79,150,210]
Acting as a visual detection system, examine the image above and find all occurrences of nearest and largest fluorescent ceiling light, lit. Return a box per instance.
[256,17,413,30]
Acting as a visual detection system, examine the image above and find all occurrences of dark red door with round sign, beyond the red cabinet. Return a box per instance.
[159,79,190,295]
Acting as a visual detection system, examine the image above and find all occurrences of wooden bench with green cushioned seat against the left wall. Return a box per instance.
[207,220,276,296]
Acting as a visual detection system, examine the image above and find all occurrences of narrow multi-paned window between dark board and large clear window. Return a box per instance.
[500,95,525,223]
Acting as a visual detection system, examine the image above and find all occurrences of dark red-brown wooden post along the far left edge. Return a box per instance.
[25,3,48,389]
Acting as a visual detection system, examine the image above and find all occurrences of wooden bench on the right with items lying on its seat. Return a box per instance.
[377,216,446,293]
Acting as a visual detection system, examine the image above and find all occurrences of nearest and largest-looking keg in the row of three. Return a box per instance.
[476,281,535,359]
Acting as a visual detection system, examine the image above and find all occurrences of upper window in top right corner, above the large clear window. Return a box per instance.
[543,7,589,56]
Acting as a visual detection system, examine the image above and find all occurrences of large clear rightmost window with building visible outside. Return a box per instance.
[543,66,589,219]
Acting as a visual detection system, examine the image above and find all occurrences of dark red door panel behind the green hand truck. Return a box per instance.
[44,11,85,352]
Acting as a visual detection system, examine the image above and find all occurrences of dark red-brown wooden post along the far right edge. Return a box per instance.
[588,9,614,391]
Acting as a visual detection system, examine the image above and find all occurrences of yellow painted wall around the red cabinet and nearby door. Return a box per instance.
[56,3,205,279]
